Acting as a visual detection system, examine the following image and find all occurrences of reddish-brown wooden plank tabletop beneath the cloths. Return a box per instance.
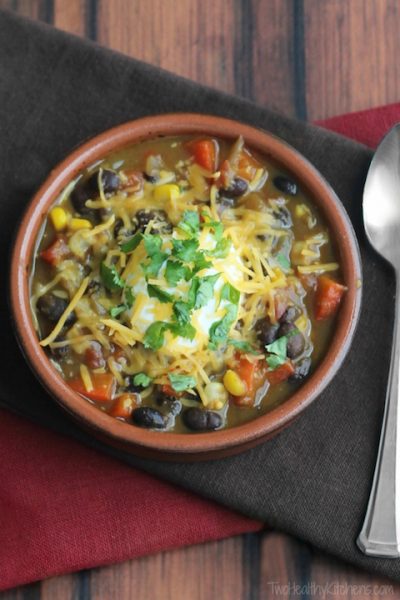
[0,0,400,600]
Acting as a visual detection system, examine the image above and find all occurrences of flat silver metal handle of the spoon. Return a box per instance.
[357,272,400,558]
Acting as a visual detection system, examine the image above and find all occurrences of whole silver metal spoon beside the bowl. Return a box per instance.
[357,124,400,558]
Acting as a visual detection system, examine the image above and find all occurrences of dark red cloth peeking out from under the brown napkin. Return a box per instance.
[0,104,400,589]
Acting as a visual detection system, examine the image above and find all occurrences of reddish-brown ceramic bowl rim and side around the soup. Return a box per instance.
[11,114,361,460]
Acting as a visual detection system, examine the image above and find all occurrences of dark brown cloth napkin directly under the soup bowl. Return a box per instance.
[0,13,400,580]
